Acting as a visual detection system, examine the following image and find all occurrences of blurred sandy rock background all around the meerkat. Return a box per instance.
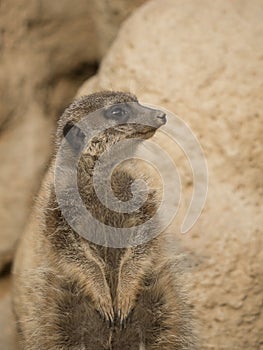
[0,0,263,350]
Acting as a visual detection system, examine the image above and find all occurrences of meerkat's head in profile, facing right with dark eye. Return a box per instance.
[58,91,166,155]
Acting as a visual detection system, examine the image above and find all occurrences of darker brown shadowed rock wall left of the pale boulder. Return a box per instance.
[0,0,148,271]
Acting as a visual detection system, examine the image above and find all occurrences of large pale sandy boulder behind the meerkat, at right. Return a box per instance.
[78,0,263,350]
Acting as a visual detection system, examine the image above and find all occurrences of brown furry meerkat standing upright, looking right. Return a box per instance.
[13,91,196,350]
